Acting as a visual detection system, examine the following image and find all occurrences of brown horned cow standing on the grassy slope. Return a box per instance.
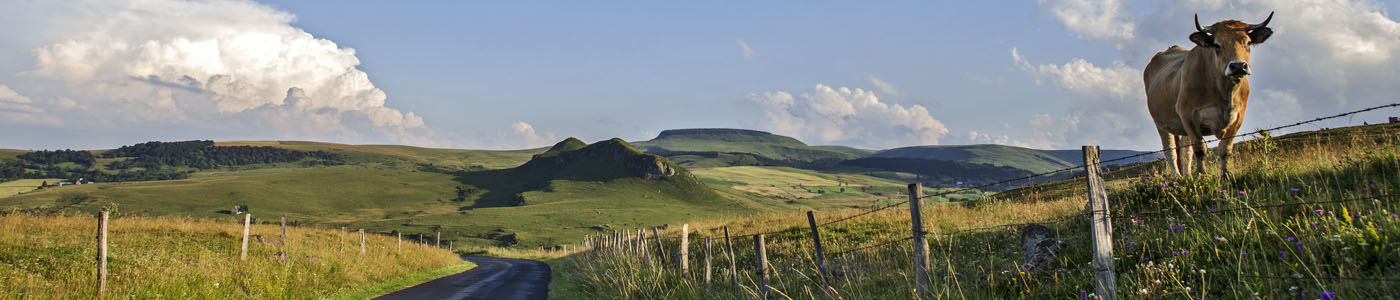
[1142,13,1274,178]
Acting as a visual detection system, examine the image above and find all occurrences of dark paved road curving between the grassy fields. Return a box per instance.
[378,257,549,300]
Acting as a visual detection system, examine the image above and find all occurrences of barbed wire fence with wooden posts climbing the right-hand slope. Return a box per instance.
[571,104,1400,299]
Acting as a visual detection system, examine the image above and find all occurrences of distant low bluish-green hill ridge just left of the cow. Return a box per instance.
[871,144,1156,172]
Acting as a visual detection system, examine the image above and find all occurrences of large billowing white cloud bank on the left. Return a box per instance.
[0,0,442,144]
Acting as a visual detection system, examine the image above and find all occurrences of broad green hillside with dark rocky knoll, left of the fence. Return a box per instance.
[0,139,767,247]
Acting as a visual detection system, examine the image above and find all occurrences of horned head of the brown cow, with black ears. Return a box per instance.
[1191,13,1274,80]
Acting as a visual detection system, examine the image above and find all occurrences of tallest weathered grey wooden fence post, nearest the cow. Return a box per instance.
[1084,146,1117,300]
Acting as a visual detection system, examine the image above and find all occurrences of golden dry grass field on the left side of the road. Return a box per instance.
[0,213,470,299]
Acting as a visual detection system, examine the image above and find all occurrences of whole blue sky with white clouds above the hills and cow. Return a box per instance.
[0,0,1400,150]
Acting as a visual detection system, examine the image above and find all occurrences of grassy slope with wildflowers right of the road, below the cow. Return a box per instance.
[556,125,1400,299]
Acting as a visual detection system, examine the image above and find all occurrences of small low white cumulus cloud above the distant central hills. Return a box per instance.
[748,84,948,147]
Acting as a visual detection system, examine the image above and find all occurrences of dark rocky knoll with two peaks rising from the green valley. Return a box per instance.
[517,137,682,179]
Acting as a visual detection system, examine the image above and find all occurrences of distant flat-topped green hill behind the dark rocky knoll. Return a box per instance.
[634,129,861,167]
